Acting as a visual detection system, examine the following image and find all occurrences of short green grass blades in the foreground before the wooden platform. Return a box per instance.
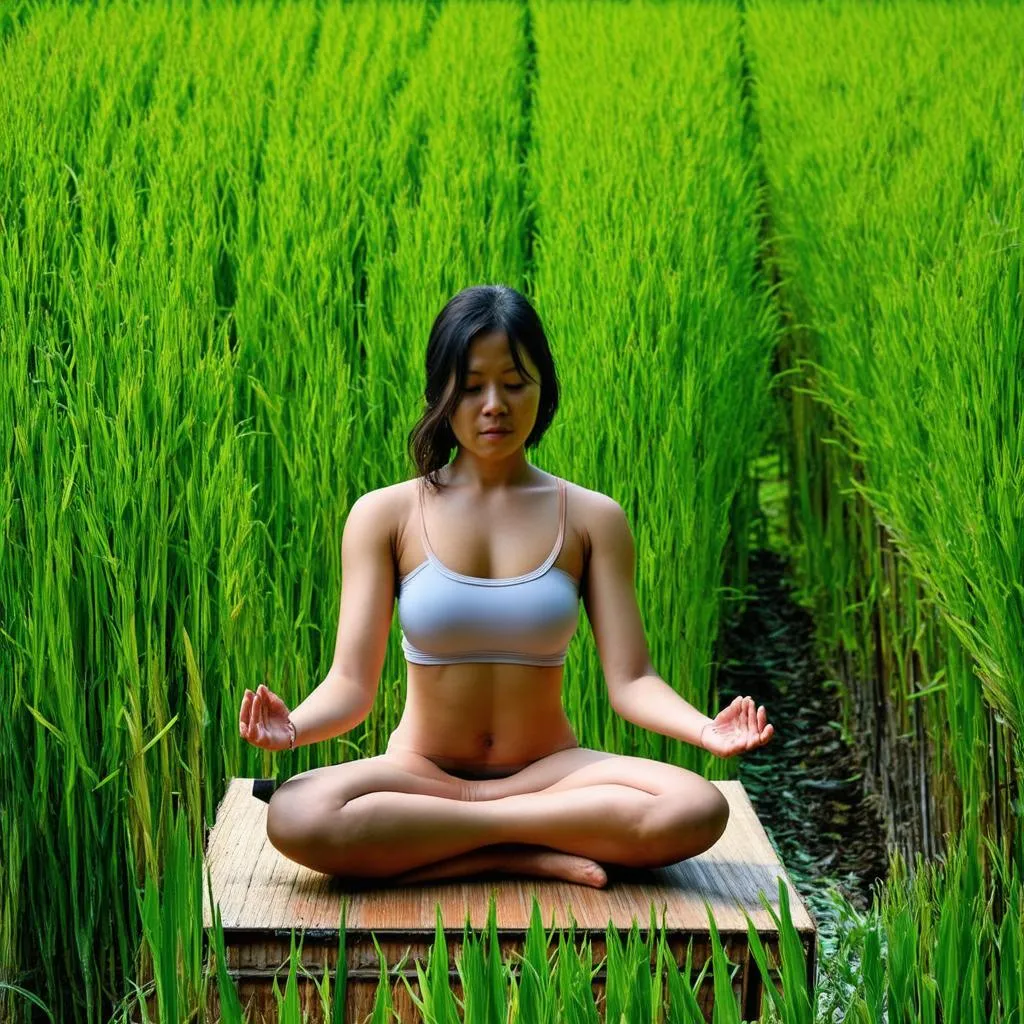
[103,816,1024,1024]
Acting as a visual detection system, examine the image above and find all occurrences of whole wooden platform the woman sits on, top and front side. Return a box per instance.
[204,778,816,1022]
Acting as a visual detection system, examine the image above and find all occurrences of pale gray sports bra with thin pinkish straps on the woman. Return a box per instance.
[398,477,580,665]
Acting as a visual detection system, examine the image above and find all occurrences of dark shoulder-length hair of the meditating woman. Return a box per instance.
[409,285,558,489]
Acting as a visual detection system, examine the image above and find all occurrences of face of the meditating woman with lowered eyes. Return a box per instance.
[449,332,541,456]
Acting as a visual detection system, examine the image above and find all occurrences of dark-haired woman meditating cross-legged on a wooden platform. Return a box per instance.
[239,286,773,887]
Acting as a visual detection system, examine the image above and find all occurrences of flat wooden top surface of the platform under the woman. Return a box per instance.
[204,778,816,936]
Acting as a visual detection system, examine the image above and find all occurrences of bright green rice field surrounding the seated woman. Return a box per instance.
[0,0,1024,1024]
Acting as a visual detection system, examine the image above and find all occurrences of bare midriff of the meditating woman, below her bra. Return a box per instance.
[387,663,579,778]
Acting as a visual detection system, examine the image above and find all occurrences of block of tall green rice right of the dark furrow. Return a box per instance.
[745,0,1024,870]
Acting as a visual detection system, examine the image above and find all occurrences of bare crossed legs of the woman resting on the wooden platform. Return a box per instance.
[267,748,728,886]
